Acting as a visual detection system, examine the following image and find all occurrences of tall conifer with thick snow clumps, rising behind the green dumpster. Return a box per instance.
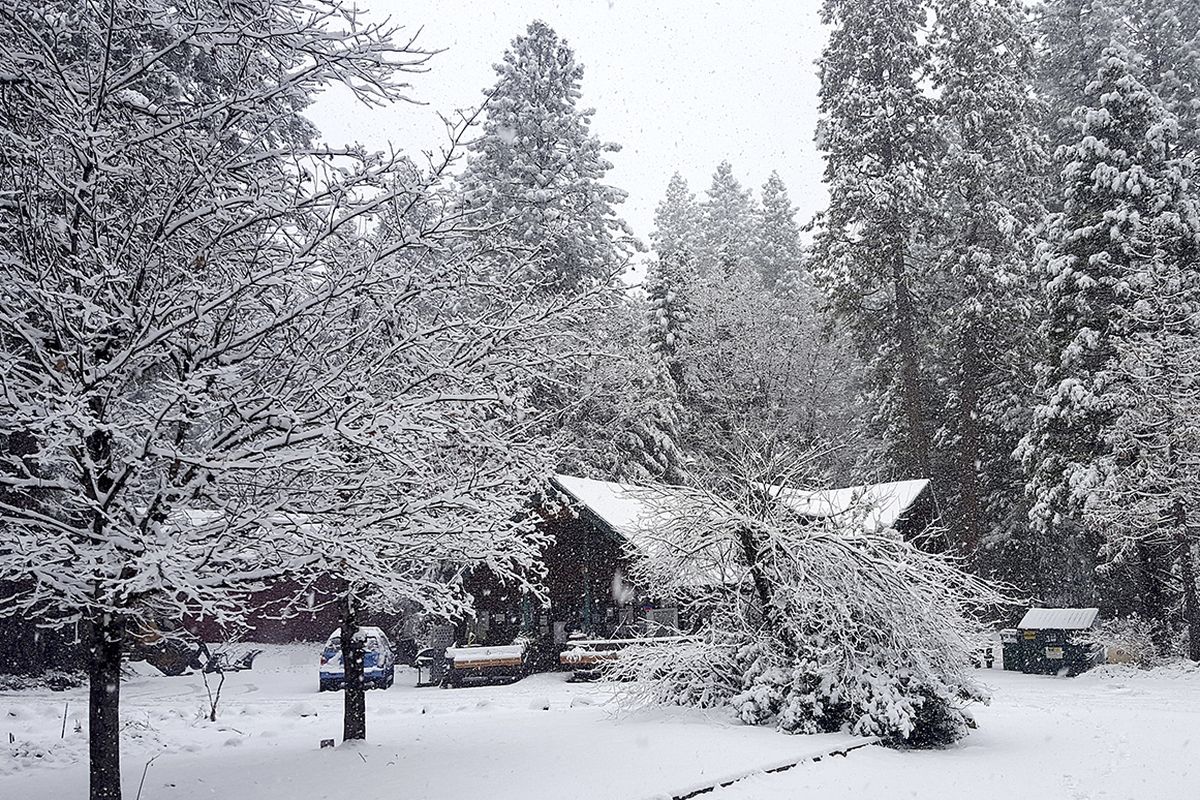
[1018,46,1185,620]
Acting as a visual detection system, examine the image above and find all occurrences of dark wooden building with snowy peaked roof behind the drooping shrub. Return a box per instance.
[460,475,936,668]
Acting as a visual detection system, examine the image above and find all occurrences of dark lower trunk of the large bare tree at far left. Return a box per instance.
[88,613,125,800]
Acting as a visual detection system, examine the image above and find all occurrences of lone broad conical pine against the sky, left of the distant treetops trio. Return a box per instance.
[462,20,637,297]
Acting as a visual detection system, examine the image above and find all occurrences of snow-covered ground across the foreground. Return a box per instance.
[0,645,1200,800]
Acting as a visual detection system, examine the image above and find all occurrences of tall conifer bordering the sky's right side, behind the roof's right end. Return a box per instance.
[812,0,936,479]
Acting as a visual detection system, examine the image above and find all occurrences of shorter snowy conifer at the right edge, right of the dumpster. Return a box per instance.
[1085,263,1200,661]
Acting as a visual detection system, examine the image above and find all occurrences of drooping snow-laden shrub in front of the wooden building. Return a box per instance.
[611,482,1004,746]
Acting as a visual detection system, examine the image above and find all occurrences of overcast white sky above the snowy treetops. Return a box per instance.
[310,0,826,247]
